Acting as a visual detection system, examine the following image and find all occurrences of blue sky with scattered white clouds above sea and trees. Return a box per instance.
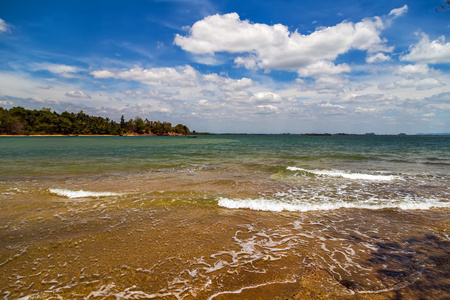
[0,0,450,134]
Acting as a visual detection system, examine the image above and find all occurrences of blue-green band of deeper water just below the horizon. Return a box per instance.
[0,135,450,179]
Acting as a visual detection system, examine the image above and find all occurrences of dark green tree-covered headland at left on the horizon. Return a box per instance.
[0,106,190,136]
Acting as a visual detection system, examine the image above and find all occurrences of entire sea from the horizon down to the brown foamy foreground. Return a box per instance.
[0,135,450,300]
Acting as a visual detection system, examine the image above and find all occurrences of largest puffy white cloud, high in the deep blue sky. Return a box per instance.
[174,6,407,70]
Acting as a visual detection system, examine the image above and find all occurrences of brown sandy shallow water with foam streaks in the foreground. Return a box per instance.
[0,165,450,299]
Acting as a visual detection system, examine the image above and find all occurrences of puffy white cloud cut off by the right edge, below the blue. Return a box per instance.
[400,33,450,64]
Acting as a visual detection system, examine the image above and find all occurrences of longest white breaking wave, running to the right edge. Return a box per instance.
[218,198,450,212]
